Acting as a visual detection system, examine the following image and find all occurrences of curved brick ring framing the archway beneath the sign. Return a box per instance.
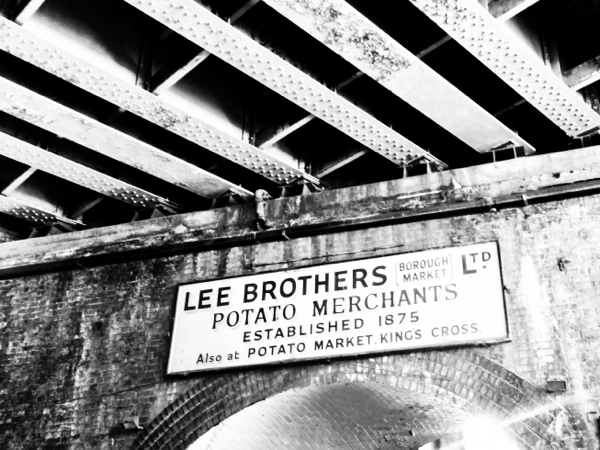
[132,349,582,450]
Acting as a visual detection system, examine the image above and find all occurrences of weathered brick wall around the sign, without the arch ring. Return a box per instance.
[0,148,600,449]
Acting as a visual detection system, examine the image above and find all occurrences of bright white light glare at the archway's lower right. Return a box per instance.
[463,418,520,450]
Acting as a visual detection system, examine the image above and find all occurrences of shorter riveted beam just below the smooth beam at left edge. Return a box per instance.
[0,133,181,210]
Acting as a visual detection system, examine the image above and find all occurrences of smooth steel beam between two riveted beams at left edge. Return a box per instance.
[0,78,253,198]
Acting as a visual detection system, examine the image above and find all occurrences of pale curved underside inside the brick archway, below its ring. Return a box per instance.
[188,382,469,450]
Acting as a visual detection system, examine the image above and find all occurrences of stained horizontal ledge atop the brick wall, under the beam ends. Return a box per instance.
[0,146,600,278]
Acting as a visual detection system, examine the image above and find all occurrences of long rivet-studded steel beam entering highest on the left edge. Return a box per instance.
[0,18,319,184]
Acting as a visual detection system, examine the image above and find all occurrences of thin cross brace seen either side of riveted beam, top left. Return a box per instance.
[150,0,260,94]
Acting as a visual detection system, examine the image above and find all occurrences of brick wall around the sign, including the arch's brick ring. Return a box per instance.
[0,154,600,449]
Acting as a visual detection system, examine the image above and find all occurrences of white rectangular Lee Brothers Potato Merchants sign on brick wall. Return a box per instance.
[167,242,508,374]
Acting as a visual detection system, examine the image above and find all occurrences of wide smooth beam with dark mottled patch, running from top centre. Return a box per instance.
[263,0,534,153]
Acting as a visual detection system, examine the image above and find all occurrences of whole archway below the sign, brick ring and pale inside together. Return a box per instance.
[134,349,582,450]
